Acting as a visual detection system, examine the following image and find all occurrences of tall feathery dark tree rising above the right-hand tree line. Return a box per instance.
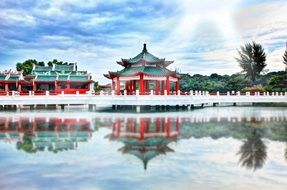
[235,41,266,83]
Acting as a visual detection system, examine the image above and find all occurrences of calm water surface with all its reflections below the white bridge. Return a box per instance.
[0,107,287,190]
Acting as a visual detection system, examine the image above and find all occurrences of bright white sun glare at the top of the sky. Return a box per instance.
[177,0,243,39]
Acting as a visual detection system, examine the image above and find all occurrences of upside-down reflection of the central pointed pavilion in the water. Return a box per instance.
[107,118,180,169]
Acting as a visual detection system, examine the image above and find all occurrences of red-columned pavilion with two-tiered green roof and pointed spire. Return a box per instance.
[104,44,182,95]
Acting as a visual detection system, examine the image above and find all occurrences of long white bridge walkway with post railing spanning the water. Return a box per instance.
[0,90,287,106]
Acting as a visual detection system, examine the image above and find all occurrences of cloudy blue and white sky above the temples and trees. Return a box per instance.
[0,0,287,83]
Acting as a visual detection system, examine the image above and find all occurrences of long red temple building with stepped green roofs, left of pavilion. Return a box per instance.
[0,63,94,94]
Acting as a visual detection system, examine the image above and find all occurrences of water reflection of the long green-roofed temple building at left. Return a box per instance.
[0,117,93,153]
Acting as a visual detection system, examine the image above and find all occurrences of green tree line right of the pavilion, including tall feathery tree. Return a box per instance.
[181,42,287,92]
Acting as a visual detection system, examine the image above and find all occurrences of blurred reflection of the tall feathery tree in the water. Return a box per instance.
[237,128,267,171]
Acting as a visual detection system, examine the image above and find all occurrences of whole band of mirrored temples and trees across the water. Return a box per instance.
[0,113,287,170]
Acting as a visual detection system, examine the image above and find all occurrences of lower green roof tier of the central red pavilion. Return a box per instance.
[111,66,174,76]
